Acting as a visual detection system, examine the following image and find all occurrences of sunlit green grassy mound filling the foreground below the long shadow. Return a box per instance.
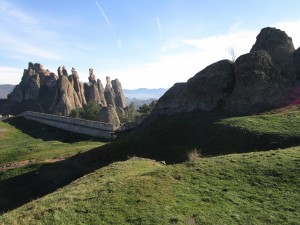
[0,147,300,224]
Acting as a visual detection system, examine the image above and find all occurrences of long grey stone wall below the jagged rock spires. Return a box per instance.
[19,111,120,139]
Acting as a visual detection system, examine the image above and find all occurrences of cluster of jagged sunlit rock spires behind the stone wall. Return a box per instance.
[1,62,126,122]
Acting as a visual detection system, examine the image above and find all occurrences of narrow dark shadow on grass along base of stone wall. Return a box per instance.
[3,117,107,143]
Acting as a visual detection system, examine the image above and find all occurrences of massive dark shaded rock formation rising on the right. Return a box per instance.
[148,28,300,121]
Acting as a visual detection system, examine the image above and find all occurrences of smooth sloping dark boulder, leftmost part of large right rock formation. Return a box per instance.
[153,60,235,114]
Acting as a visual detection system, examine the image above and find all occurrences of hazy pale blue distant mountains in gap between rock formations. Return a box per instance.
[123,88,168,100]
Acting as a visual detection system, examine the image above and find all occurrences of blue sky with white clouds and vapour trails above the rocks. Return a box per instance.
[0,0,300,89]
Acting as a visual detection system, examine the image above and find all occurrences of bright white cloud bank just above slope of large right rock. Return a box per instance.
[109,27,258,89]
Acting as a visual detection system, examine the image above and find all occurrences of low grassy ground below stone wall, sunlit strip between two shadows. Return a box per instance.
[0,118,106,212]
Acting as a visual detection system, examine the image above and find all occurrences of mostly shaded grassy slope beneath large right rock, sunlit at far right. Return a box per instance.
[90,110,300,163]
